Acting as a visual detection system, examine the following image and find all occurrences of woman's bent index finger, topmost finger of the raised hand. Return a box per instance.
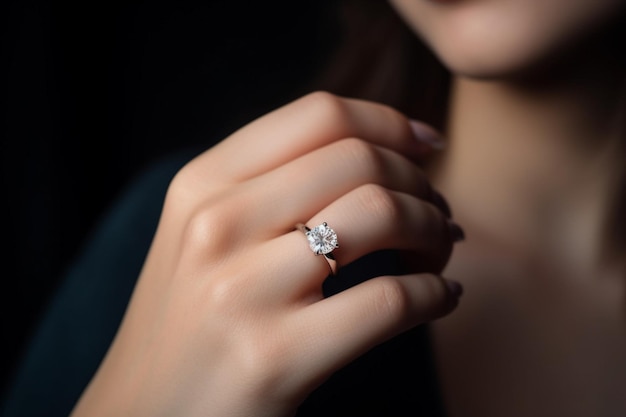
[188,92,436,182]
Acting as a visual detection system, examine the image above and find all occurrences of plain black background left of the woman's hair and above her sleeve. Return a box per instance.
[0,0,338,396]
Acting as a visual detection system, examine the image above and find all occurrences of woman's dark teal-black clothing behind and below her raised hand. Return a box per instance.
[2,152,444,417]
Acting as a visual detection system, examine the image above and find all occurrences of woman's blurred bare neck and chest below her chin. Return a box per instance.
[432,80,626,417]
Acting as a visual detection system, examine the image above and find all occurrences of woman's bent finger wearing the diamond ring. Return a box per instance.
[258,184,455,291]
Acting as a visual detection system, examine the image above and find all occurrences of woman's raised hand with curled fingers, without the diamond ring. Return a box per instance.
[74,93,458,417]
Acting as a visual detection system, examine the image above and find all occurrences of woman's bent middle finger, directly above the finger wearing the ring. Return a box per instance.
[234,138,434,238]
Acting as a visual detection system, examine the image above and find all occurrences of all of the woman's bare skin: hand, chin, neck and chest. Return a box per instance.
[73,0,626,417]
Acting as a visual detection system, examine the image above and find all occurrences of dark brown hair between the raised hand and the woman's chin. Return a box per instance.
[318,0,450,129]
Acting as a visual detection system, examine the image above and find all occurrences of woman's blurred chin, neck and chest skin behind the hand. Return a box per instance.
[393,0,626,417]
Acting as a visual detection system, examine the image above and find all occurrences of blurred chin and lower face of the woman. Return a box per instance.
[390,0,626,78]
